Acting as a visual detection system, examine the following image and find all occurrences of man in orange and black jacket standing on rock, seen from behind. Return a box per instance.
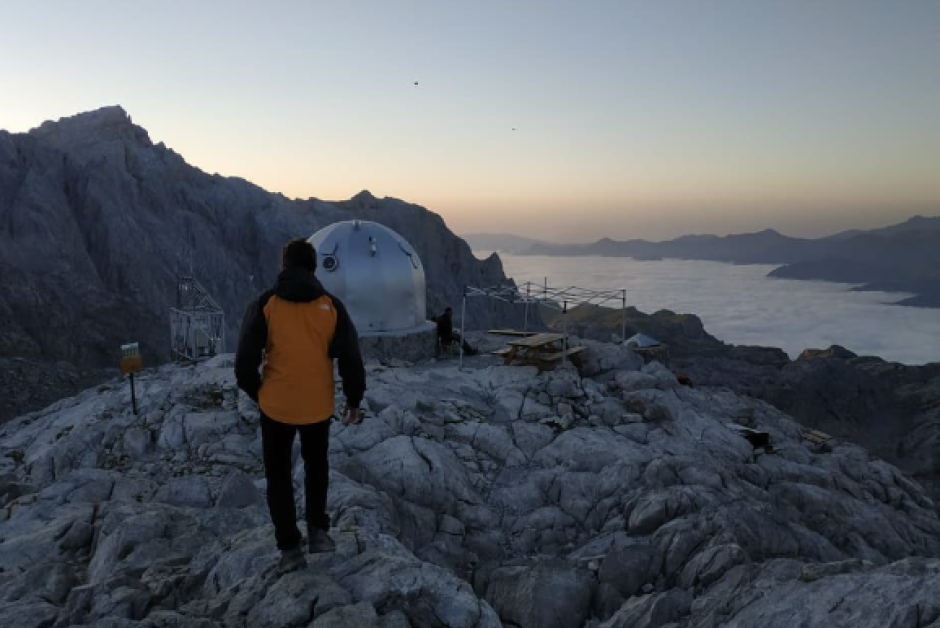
[235,239,366,572]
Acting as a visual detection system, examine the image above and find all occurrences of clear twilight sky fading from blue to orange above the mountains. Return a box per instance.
[0,0,940,241]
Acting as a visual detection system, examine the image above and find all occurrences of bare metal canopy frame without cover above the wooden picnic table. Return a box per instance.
[460,277,627,366]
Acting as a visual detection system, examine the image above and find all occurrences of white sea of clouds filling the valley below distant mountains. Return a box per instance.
[476,252,940,364]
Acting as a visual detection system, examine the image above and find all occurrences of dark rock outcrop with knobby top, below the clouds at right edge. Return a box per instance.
[675,347,940,512]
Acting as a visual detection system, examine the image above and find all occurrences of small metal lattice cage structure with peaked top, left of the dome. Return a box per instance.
[170,276,225,361]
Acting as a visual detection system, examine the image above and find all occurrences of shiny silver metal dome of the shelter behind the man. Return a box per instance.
[308,220,427,335]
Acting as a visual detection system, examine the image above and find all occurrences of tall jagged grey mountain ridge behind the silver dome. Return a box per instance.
[0,107,518,421]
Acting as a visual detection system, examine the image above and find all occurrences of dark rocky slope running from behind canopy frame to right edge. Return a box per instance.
[547,307,940,510]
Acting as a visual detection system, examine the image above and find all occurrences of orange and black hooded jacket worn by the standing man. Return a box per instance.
[235,268,366,425]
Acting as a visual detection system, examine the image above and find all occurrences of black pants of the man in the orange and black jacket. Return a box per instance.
[261,413,330,550]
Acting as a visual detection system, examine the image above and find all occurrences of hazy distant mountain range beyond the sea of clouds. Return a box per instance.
[465,216,940,307]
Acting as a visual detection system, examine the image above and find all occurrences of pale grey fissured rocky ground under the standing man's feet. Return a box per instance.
[0,339,940,628]
